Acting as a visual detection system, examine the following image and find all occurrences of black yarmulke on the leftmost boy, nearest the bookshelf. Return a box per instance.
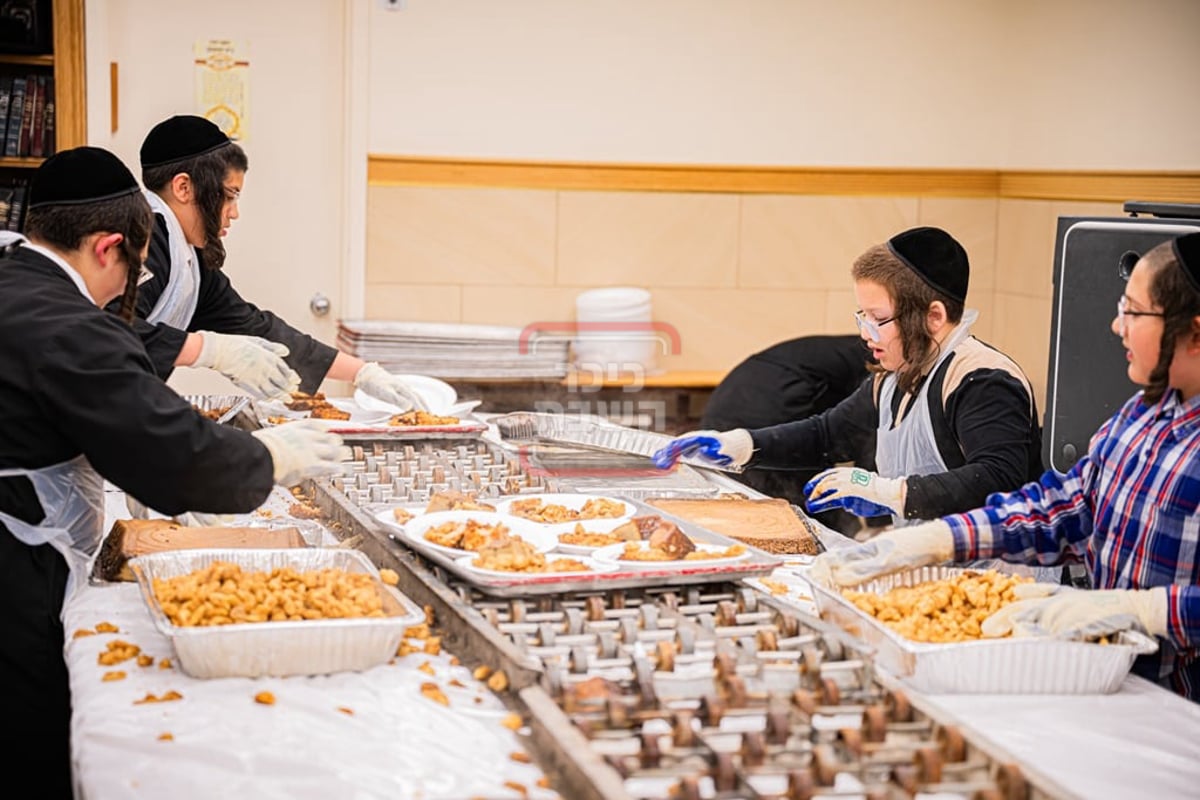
[29,148,142,209]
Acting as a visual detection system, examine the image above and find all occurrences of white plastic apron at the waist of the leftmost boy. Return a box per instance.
[0,455,104,606]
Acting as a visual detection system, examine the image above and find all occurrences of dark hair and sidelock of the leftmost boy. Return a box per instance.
[25,192,154,323]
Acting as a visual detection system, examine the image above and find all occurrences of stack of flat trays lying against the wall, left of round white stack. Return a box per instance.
[337,319,570,378]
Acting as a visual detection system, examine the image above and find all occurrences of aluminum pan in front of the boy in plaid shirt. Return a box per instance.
[812,566,1158,694]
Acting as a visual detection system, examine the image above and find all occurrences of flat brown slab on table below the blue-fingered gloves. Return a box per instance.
[647,498,820,555]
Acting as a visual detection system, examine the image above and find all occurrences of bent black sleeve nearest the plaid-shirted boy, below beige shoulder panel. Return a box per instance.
[905,369,1038,519]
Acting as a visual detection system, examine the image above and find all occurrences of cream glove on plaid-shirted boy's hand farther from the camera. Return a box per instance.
[808,519,954,587]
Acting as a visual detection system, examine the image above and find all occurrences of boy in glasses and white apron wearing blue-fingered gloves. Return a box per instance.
[655,227,1043,524]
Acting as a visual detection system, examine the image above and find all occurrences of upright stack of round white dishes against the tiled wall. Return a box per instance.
[575,287,661,374]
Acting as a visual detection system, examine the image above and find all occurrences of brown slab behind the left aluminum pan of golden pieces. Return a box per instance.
[92,519,306,581]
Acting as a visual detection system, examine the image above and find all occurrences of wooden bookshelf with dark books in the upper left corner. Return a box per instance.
[0,0,88,230]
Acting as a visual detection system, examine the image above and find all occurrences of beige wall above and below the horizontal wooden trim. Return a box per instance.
[364,0,1200,410]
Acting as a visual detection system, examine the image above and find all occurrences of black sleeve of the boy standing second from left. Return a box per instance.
[187,269,337,392]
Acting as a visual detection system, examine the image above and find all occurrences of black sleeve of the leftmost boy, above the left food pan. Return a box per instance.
[37,315,274,515]
